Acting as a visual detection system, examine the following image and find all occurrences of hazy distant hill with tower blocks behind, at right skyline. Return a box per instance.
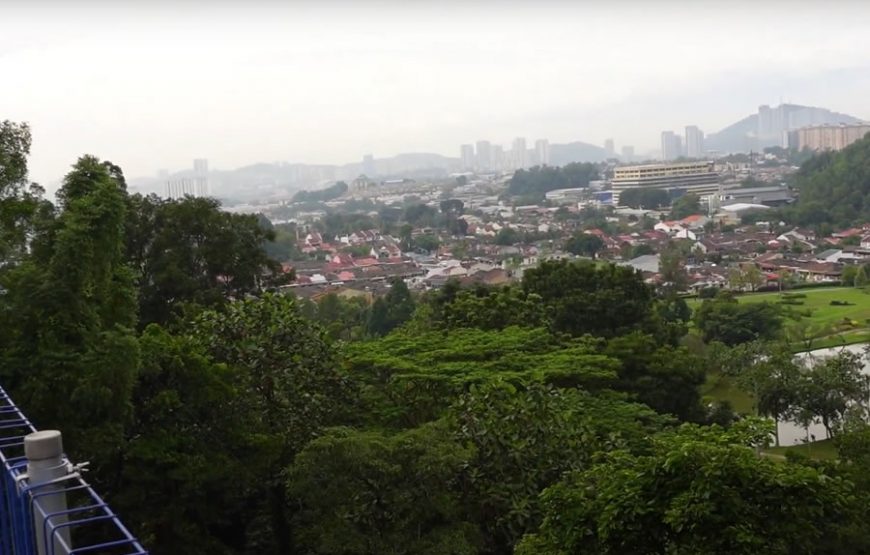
[704,104,861,153]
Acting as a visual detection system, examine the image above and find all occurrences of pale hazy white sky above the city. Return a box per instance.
[0,0,870,189]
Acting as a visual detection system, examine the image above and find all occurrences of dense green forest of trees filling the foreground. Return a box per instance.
[0,122,870,555]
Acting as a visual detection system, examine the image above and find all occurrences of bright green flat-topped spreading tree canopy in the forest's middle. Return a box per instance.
[347,328,618,426]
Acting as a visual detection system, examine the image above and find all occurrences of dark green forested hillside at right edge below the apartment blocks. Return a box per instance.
[789,137,870,228]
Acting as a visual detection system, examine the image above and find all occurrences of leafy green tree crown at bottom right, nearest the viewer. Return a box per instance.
[517,428,861,555]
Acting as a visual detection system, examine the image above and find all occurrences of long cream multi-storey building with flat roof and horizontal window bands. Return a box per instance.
[610,161,719,206]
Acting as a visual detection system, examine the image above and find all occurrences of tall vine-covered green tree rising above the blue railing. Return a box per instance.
[2,156,138,461]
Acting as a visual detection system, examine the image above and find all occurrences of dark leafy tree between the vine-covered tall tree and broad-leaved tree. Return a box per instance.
[113,324,242,555]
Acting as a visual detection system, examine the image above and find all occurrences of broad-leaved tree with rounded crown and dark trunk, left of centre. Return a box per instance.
[190,294,348,553]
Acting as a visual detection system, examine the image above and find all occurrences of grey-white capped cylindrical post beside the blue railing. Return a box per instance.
[24,430,70,555]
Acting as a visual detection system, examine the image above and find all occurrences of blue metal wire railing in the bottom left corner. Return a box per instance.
[0,388,148,555]
